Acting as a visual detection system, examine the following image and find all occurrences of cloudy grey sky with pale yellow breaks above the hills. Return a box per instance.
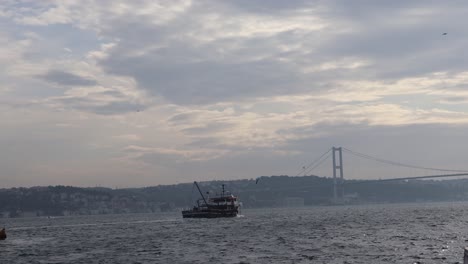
[0,0,468,188]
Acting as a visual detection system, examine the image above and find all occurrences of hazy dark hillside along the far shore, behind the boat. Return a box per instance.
[0,176,468,217]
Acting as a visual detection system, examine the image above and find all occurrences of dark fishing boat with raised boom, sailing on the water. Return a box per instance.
[182,182,239,218]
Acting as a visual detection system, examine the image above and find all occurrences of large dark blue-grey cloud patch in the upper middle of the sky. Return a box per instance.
[102,40,304,104]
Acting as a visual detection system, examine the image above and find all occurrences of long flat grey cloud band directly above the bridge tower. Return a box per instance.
[284,123,468,157]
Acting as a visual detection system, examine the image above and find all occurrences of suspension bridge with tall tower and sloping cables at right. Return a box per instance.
[296,147,468,201]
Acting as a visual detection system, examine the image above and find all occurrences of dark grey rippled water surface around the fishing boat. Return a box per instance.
[0,203,468,263]
